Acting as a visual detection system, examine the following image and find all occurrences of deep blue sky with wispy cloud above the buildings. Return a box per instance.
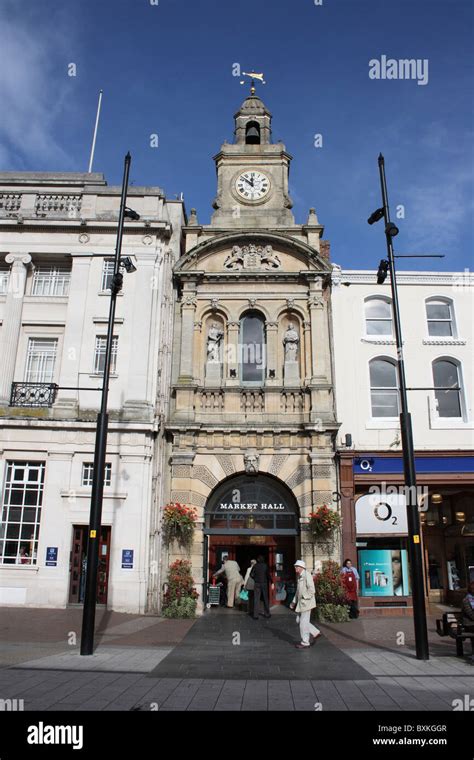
[0,0,474,270]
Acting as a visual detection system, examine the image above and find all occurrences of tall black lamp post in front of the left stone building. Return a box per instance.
[81,153,140,655]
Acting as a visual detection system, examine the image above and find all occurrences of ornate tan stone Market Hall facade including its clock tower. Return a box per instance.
[167,91,339,608]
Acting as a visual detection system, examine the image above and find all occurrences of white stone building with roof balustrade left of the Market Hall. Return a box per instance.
[0,173,184,613]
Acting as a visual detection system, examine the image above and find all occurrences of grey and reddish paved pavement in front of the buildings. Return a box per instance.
[0,608,474,713]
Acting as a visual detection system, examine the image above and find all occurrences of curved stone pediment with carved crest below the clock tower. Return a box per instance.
[175,232,331,276]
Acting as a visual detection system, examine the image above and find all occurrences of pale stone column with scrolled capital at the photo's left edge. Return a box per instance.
[0,253,31,405]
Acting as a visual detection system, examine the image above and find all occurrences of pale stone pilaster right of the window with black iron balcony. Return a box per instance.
[54,255,92,418]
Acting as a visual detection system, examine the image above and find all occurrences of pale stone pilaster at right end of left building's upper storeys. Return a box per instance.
[123,251,162,419]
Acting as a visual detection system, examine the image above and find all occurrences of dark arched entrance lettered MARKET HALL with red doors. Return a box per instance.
[204,474,299,604]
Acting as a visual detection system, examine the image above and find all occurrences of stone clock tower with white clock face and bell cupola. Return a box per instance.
[211,84,295,229]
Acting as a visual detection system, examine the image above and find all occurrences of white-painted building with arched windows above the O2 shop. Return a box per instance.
[332,266,474,614]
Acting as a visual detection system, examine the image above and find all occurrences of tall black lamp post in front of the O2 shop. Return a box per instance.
[367,154,430,660]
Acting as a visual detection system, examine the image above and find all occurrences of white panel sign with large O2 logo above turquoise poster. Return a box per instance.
[355,493,408,536]
